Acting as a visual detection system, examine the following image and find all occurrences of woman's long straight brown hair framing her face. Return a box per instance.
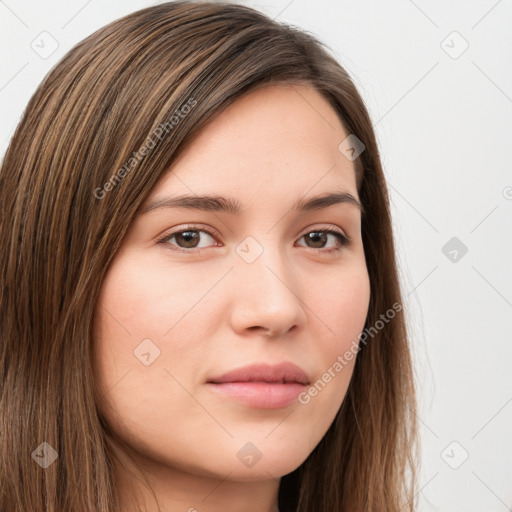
[0,1,418,512]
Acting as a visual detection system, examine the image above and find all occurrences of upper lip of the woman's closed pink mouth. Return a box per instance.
[208,362,309,384]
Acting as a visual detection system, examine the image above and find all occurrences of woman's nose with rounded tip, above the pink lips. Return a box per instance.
[231,247,306,337]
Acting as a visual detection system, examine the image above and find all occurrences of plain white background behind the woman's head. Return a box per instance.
[0,0,512,512]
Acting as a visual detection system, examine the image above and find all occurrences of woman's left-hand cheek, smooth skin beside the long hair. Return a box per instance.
[93,251,226,416]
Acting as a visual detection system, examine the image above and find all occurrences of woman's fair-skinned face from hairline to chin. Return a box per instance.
[94,85,370,488]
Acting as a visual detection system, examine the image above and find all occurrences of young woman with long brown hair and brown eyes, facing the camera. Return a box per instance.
[0,1,417,512]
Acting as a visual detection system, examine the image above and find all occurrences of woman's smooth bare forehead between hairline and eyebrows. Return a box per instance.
[148,85,357,204]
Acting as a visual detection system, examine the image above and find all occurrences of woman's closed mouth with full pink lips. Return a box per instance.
[206,363,310,409]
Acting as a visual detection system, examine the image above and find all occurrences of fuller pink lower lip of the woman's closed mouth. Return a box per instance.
[207,382,306,409]
